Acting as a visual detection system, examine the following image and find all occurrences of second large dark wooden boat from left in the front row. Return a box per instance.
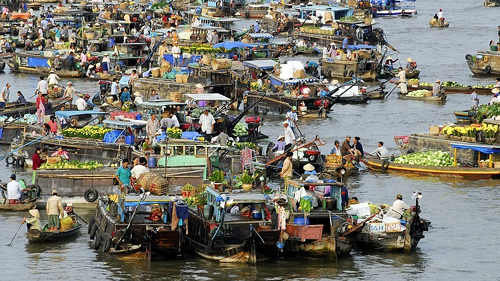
[184,187,280,264]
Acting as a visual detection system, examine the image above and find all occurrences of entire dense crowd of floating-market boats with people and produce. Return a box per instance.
[0,0,500,264]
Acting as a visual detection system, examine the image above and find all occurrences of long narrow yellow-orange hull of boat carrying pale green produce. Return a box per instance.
[362,159,500,179]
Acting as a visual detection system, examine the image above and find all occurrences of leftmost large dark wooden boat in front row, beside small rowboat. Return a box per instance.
[89,193,183,259]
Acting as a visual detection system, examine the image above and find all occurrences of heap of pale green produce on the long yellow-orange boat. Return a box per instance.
[394,150,453,167]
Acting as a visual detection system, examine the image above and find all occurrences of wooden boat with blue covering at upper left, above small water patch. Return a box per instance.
[7,51,83,78]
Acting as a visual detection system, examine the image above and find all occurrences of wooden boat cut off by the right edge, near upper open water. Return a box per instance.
[465,50,500,76]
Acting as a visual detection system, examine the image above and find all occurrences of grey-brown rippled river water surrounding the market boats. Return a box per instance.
[0,0,500,280]
